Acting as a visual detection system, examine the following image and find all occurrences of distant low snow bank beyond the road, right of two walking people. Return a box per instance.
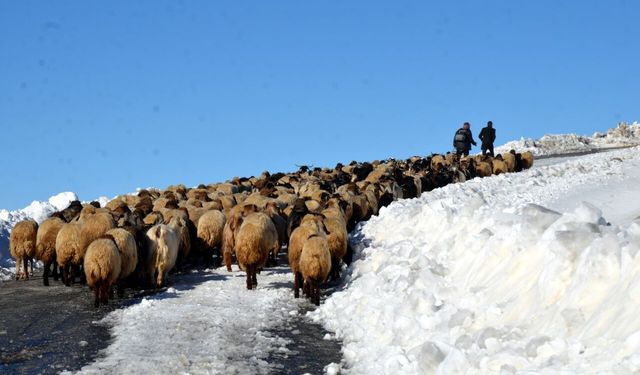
[496,122,640,156]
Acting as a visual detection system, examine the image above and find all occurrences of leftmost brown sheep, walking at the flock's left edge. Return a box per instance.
[9,220,38,280]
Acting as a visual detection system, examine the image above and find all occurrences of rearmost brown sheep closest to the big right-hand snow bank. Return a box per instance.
[300,235,332,306]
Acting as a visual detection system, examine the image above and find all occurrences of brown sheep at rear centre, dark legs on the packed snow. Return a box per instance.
[235,212,279,290]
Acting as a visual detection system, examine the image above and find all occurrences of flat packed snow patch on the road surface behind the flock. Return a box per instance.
[74,266,303,374]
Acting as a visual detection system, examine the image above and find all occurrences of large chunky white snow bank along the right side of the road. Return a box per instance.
[311,148,640,374]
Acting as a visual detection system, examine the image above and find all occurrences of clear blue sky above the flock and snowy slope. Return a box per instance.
[0,0,640,209]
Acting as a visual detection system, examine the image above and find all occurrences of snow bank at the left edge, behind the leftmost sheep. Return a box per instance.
[0,192,78,280]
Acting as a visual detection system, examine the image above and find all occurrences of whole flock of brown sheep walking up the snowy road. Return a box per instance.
[10,151,533,307]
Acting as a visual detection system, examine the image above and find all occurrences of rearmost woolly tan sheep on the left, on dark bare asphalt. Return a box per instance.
[84,235,122,307]
